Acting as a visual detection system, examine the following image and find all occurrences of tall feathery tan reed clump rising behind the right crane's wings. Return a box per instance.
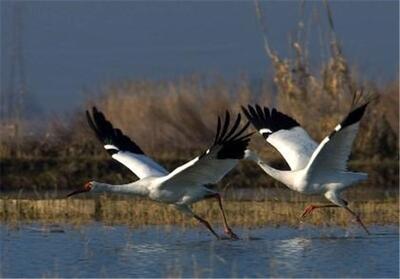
[255,1,399,159]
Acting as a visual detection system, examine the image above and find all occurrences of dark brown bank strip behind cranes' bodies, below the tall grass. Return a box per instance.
[1,158,399,192]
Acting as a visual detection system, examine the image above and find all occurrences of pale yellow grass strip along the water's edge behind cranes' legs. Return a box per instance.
[0,197,399,227]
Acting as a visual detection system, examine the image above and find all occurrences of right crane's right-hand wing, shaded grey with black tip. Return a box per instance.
[307,103,368,177]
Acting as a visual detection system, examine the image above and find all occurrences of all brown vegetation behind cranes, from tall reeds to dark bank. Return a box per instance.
[0,1,399,189]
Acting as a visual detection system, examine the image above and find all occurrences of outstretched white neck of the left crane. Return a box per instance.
[92,181,149,197]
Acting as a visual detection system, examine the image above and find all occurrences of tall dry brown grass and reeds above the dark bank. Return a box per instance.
[5,1,399,160]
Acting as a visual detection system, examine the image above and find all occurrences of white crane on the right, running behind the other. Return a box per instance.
[242,103,369,234]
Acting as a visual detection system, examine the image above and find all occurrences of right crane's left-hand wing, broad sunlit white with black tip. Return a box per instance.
[242,105,317,170]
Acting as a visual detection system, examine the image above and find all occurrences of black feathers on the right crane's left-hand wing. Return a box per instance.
[242,105,300,139]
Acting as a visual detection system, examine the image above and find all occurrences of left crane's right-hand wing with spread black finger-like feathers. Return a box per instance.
[161,111,251,188]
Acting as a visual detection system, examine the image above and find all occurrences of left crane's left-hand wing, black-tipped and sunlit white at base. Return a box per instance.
[86,107,168,178]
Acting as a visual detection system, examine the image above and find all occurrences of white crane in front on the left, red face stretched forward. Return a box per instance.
[68,107,251,239]
